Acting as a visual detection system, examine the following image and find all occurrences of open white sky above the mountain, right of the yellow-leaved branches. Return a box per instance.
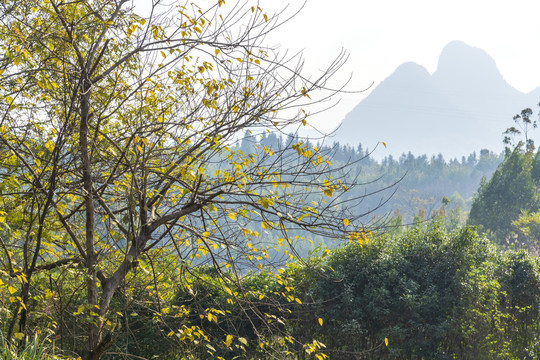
[260,0,540,130]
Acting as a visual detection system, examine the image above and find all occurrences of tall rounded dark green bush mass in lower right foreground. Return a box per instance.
[288,226,540,359]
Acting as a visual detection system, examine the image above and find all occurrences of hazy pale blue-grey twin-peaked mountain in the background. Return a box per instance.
[334,41,540,158]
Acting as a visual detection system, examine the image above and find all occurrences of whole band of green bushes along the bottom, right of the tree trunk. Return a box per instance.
[10,225,528,359]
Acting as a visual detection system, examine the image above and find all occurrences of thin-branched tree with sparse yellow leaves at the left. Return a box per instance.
[0,0,382,360]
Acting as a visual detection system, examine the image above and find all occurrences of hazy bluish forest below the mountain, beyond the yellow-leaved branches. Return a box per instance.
[238,132,504,228]
